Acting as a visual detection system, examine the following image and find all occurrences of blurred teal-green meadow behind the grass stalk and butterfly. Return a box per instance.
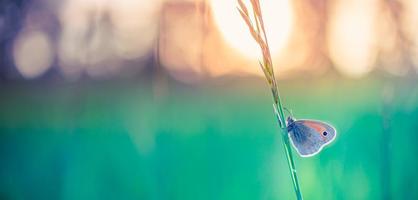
[0,75,418,200]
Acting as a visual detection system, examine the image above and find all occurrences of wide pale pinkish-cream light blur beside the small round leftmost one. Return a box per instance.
[57,0,161,79]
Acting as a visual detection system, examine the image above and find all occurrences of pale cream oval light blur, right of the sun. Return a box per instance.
[328,0,377,77]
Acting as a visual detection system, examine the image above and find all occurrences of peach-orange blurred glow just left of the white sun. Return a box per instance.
[158,3,204,83]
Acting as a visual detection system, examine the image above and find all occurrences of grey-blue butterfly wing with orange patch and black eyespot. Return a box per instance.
[289,120,337,157]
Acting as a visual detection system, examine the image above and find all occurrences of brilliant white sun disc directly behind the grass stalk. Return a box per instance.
[211,0,293,59]
